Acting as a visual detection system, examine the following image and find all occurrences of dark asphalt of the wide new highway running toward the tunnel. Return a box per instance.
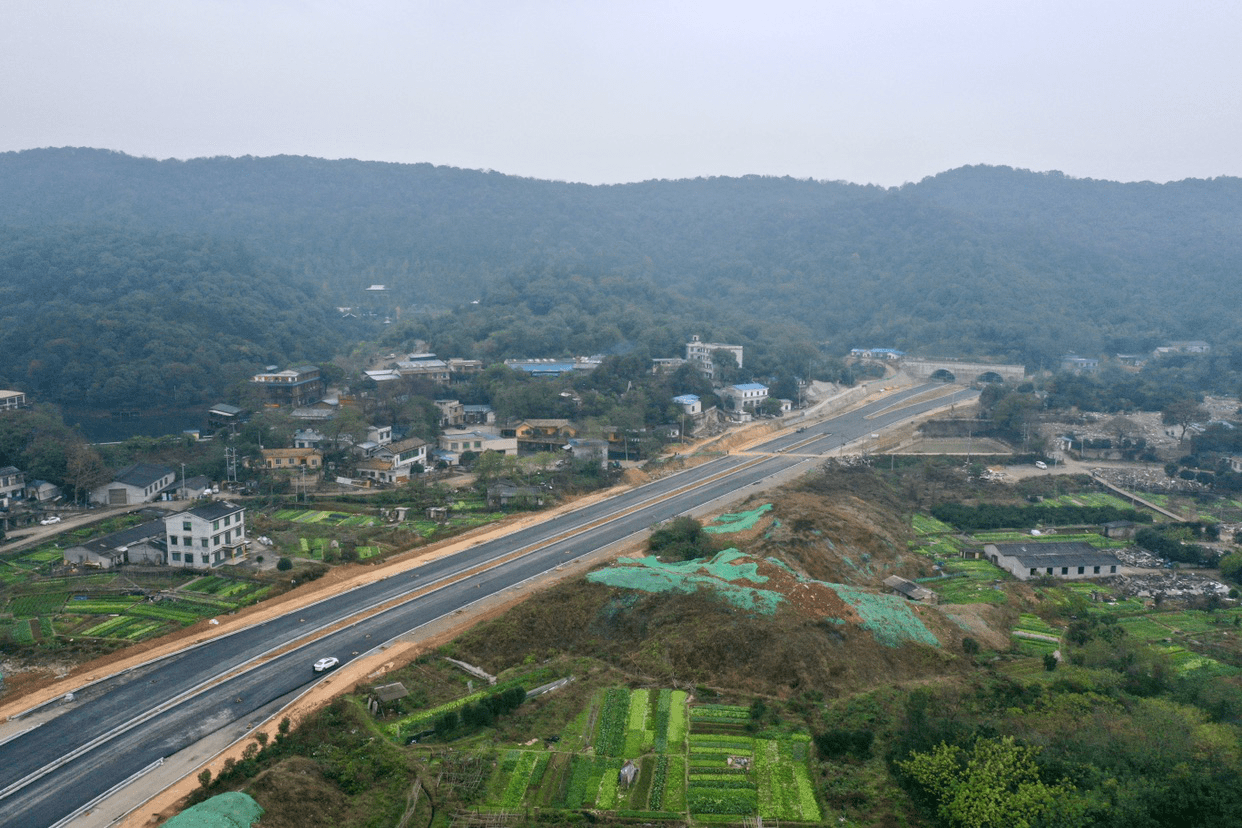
[0,385,975,828]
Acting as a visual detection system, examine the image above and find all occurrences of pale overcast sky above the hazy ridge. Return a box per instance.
[0,0,1242,186]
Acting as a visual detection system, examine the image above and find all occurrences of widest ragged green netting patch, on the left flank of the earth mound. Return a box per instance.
[586,549,784,614]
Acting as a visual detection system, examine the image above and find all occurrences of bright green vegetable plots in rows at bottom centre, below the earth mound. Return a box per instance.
[476,688,822,823]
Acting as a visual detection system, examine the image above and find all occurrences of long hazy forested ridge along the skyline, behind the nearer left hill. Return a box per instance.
[0,149,1242,389]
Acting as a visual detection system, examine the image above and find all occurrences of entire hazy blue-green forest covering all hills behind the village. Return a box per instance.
[0,149,1242,405]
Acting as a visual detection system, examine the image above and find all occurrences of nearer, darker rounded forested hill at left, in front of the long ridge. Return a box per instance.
[0,227,339,410]
